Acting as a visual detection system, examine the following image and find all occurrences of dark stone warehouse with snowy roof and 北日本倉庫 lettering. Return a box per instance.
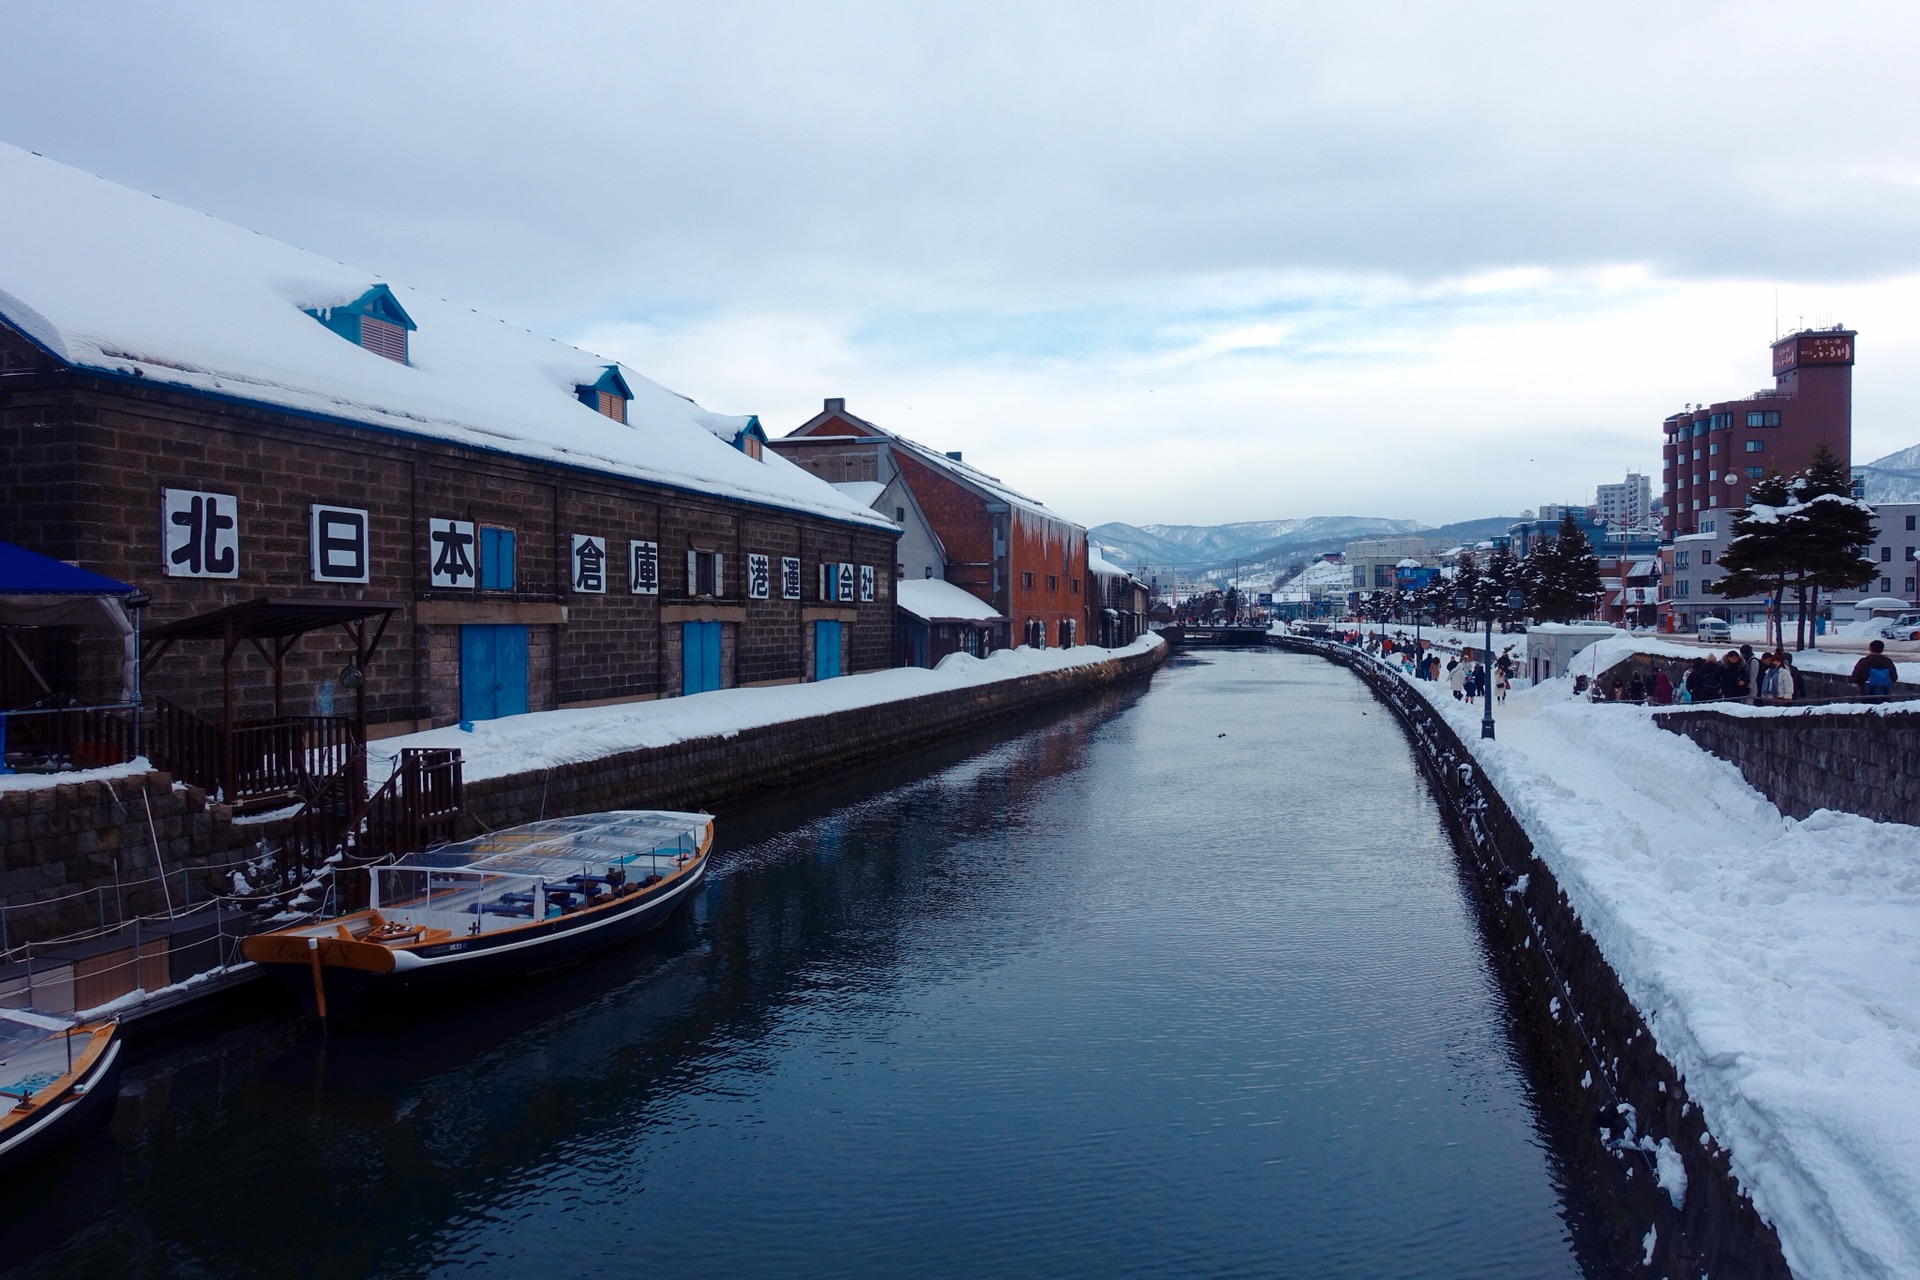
[0,146,899,735]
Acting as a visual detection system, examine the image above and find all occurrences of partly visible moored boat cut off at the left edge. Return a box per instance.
[0,1009,121,1178]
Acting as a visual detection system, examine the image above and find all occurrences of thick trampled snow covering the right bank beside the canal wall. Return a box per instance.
[1411,656,1920,1278]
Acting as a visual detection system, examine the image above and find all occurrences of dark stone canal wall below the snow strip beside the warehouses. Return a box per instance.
[456,645,1167,835]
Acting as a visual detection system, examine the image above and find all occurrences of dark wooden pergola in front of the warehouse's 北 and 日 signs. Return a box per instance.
[140,597,399,800]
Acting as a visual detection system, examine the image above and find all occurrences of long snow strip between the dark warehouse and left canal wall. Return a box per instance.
[367,635,1165,783]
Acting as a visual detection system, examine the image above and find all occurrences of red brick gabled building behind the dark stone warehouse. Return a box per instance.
[768,399,1098,647]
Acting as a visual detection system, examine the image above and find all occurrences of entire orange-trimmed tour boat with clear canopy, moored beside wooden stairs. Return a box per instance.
[242,810,712,1017]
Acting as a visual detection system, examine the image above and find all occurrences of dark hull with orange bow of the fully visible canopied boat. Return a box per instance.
[248,856,707,1017]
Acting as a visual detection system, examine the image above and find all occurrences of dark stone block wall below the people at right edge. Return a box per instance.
[1653,706,1920,825]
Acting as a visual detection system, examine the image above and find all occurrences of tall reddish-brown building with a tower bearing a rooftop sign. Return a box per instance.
[1661,324,1857,539]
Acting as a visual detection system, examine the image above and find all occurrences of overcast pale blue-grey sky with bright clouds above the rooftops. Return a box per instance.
[0,0,1920,524]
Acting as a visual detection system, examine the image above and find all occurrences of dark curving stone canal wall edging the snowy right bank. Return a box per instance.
[1273,637,1789,1278]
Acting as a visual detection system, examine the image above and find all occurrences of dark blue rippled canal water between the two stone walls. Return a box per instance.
[0,651,1603,1280]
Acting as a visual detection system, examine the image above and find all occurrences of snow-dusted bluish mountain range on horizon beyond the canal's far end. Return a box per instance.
[1087,516,1519,589]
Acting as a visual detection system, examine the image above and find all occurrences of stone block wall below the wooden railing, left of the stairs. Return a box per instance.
[0,770,253,946]
